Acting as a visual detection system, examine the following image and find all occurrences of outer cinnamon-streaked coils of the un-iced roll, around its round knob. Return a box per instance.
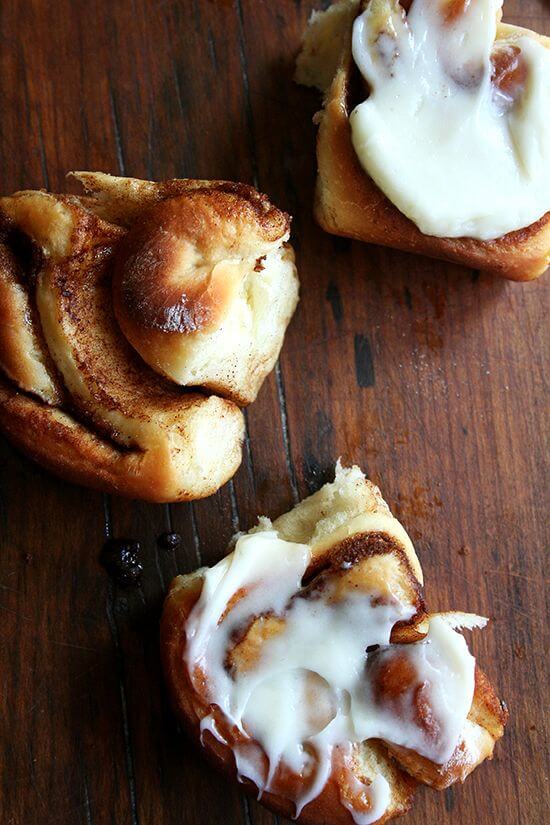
[0,180,274,501]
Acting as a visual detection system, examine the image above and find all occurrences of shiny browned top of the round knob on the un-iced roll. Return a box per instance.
[115,183,290,333]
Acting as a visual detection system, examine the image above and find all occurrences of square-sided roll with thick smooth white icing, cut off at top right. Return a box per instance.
[297,0,550,280]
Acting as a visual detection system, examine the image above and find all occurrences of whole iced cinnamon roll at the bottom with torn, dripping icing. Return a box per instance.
[161,466,506,825]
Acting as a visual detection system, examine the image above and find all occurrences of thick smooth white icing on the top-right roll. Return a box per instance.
[350,0,550,240]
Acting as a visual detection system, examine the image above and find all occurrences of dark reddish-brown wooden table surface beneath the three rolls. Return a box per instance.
[0,0,550,825]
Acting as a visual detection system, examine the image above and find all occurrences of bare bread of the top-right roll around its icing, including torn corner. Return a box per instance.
[295,0,550,281]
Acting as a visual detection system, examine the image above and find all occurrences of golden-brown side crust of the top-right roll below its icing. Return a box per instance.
[308,1,550,281]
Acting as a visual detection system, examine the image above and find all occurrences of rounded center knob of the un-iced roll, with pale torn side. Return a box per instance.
[71,172,298,405]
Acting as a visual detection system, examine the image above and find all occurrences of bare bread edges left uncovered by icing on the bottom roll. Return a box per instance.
[160,463,508,825]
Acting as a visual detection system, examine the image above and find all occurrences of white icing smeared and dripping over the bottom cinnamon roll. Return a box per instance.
[185,522,484,825]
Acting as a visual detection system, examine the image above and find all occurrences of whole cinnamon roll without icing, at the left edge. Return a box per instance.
[0,173,297,501]
